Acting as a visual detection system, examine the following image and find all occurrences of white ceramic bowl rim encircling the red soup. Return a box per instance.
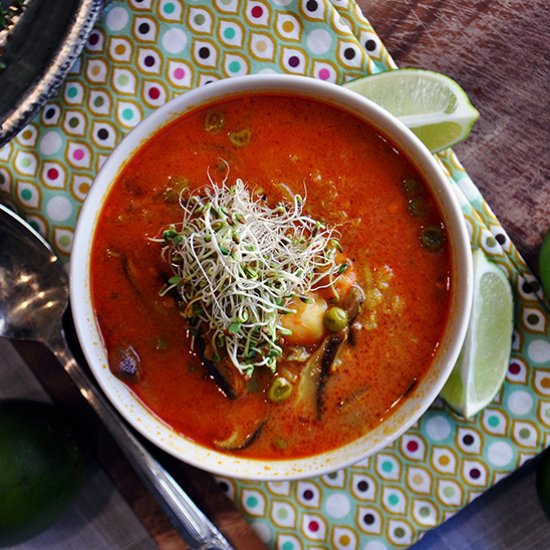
[71,75,472,480]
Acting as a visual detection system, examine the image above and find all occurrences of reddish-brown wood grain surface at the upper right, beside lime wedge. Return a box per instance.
[358,0,550,272]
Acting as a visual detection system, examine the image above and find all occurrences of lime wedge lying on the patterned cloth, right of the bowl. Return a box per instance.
[441,250,514,418]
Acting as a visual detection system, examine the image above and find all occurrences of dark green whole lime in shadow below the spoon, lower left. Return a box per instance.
[0,399,84,547]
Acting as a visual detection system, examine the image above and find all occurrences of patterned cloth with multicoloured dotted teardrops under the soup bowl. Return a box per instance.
[0,0,550,550]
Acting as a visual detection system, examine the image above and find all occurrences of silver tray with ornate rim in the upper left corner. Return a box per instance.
[0,0,107,147]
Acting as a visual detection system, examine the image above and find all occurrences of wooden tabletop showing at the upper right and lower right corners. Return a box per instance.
[359,0,550,550]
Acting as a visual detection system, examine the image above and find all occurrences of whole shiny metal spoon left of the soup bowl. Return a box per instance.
[0,204,232,550]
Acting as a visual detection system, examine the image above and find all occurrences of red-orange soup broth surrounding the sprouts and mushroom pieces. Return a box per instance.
[91,94,451,459]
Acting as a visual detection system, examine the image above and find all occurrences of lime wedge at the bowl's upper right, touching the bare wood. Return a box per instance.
[344,69,479,153]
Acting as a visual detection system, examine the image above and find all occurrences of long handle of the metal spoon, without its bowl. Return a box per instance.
[45,331,232,550]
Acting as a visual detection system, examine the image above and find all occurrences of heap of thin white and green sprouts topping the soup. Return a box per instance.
[153,176,348,376]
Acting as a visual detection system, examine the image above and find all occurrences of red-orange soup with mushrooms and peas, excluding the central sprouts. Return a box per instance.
[90,93,451,459]
